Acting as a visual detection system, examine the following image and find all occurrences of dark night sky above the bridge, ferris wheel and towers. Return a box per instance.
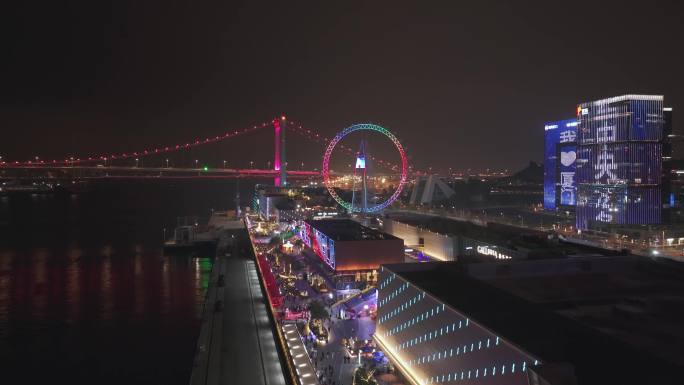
[0,0,684,169]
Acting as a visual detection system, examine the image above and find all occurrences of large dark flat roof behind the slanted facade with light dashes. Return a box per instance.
[385,257,684,385]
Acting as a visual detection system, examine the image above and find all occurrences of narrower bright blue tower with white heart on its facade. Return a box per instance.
[544,119,578,210]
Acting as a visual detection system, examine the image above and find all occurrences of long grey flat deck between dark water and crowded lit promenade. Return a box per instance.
[191,257,285,385]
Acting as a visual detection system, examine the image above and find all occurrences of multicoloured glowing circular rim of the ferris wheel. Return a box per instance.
[323,123,408,213]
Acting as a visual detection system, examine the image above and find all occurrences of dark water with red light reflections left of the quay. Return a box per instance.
[0,182,227,384]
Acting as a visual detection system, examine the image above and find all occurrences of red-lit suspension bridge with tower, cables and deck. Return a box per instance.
[0,116,408,185]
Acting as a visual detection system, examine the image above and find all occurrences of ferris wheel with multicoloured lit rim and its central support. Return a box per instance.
[323,123,408,213]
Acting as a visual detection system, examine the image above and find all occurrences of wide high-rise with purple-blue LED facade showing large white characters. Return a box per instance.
[576,95,668,229]
